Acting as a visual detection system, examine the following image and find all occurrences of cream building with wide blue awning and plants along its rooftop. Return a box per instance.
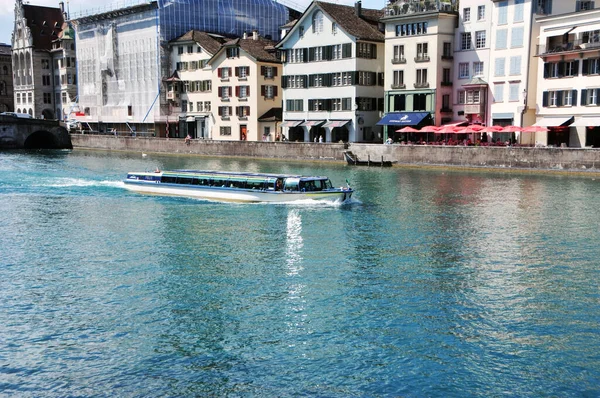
[380,0,457,141]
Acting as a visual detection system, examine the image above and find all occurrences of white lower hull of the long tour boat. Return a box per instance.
[124,180,352,203]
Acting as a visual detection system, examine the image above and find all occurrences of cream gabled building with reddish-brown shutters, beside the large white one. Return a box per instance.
[209,31,281,141]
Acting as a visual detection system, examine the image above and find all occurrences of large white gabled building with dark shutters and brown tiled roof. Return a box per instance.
[277,1,384,142]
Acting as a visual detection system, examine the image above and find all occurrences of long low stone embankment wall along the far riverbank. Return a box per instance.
[71,134,600,172]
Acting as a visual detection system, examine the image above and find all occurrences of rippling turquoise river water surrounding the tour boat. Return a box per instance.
[0,150,600,397]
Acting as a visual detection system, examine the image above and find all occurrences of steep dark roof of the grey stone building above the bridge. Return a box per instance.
[23,4,64,50]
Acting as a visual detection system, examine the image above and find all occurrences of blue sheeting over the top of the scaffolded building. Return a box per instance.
[158,0,289,41]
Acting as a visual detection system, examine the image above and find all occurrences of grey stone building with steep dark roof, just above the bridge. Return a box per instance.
[12,0,64,119]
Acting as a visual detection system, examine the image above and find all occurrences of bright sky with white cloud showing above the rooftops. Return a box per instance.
[0,0,385,44]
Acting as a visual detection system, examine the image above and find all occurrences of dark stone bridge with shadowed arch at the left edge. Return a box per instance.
[0,115,73,149]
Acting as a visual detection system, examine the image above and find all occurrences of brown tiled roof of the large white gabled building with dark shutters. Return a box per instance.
[315,1,385,42]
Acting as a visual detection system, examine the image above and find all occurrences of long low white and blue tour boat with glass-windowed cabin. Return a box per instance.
[123,170,354,203]
